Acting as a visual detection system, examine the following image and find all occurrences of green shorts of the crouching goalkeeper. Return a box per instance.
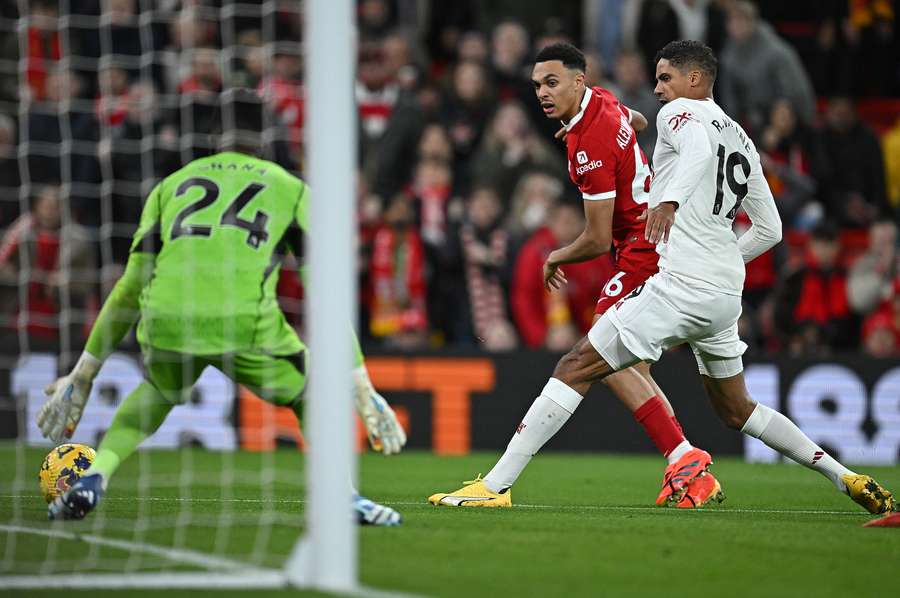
[142,346,306,406]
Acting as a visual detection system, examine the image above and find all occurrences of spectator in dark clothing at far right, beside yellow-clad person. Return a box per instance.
[820,97,890,227]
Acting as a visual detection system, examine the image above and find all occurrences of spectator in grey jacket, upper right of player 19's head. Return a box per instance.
[716,1,815,137]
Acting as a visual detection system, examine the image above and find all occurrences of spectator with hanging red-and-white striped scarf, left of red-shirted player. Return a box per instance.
[449,186,518,351]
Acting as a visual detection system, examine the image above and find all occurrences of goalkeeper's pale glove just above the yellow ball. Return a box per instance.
[37,351,102,444]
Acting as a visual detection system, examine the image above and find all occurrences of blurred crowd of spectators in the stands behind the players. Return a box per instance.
[0,0,900,357]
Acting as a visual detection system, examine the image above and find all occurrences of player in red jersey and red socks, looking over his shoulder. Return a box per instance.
[532,44,721,506]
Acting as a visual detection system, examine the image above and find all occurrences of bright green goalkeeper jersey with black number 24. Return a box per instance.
[131,152,309,355]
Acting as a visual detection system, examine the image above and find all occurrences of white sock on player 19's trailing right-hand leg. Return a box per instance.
[741,404,853,492]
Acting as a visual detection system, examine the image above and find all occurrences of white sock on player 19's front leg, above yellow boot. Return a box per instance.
[484,378,584,492]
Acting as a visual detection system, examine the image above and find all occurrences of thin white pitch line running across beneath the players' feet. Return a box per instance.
[0,495,869,517]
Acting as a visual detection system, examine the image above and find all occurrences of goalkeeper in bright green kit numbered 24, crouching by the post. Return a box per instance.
[38,91,406,525]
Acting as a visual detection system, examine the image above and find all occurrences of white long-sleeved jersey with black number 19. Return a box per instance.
[649,98,781,295]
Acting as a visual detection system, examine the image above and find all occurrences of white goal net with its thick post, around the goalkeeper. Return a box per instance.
[0,0,356,589]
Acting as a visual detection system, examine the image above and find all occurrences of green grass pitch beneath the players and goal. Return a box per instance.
[0,445,900,598]
